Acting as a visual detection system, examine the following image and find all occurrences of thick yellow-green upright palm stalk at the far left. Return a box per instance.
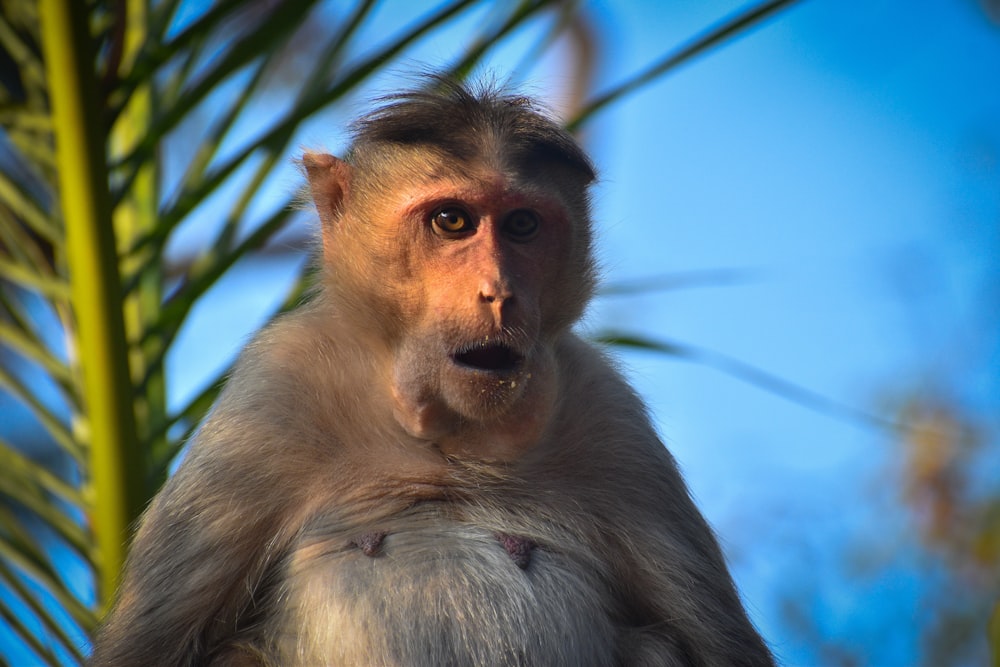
[40,0,143,601]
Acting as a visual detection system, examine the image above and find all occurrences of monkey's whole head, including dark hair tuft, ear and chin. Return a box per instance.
[303,79,595,449]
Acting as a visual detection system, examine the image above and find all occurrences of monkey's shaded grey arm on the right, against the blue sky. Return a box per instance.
[559,336,774,667]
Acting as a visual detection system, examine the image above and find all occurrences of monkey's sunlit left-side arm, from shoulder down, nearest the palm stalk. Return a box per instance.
[92,326,324,667]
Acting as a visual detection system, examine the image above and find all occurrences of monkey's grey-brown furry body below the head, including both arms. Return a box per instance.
[92,82,773,667]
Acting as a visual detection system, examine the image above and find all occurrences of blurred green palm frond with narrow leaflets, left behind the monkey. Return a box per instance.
[0,0,788,664]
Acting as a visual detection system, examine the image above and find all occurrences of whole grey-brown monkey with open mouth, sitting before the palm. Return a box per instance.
[91,77,774,667]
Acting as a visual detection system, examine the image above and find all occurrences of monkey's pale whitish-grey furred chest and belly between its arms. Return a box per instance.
[278,515,616,666]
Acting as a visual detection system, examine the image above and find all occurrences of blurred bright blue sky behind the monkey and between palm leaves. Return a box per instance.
[0,0,1000,666]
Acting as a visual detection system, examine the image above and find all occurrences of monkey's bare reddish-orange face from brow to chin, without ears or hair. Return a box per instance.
[378,166,572,436]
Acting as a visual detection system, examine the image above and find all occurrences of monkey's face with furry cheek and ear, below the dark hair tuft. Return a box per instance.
[304,150,592,452]
